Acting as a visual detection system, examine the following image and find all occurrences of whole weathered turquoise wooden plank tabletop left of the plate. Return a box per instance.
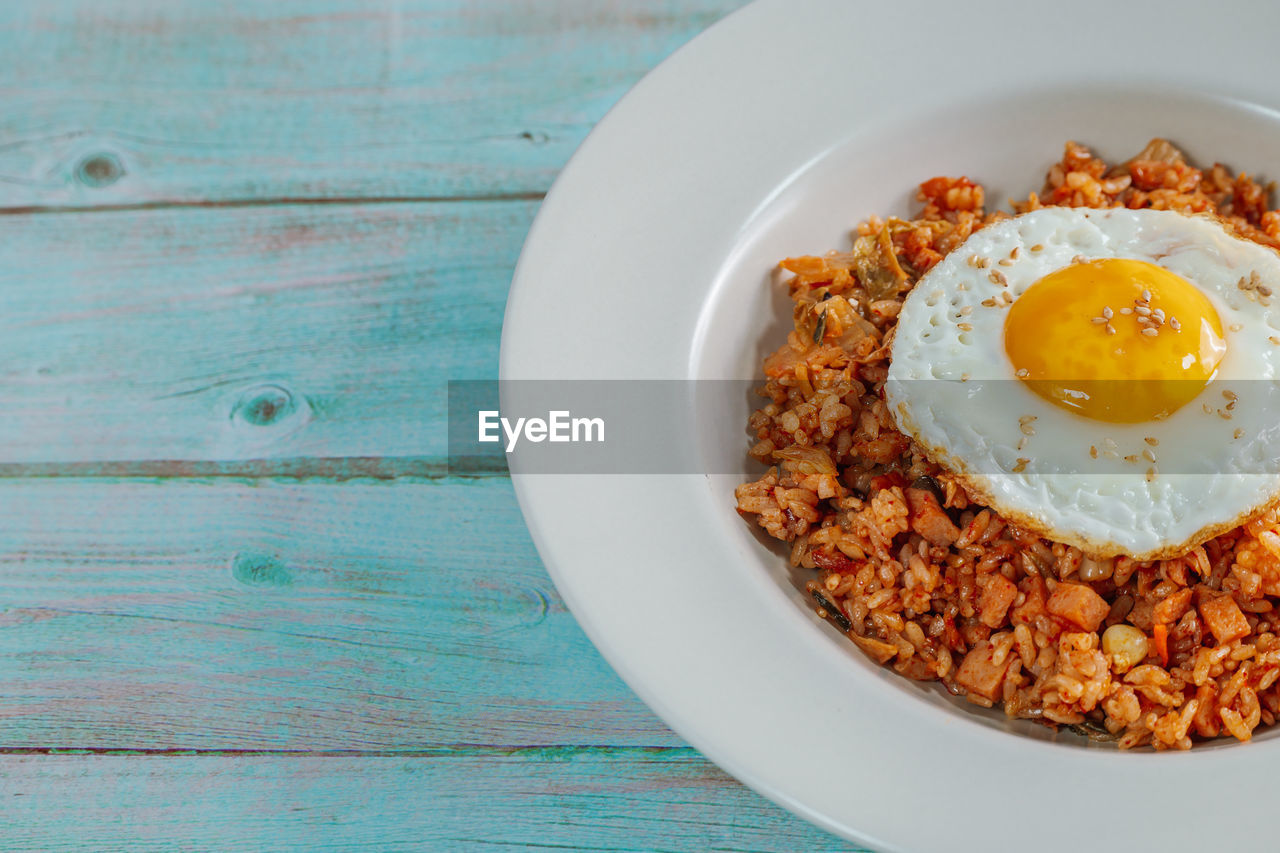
[0,0,870,852]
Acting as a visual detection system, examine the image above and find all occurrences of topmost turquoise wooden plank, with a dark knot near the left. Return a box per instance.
[0,0,744,206]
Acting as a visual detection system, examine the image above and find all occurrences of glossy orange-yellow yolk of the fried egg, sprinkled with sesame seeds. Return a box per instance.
[1005,259,1226,424]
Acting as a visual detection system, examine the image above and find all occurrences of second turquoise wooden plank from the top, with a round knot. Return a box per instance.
[0,202,524,466]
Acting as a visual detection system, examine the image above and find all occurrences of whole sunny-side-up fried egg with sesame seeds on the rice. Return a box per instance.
[884,207,1280,560]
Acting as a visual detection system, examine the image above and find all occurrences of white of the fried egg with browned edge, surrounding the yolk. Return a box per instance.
[884,207,1280,558]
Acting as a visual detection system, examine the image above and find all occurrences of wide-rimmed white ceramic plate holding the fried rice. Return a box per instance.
[500,0,1280,850]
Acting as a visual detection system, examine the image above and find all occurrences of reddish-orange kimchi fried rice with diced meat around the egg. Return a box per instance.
[736,140,1280,749]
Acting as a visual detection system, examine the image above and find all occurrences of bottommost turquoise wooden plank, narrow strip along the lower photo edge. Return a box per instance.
[0,749,856,853]
